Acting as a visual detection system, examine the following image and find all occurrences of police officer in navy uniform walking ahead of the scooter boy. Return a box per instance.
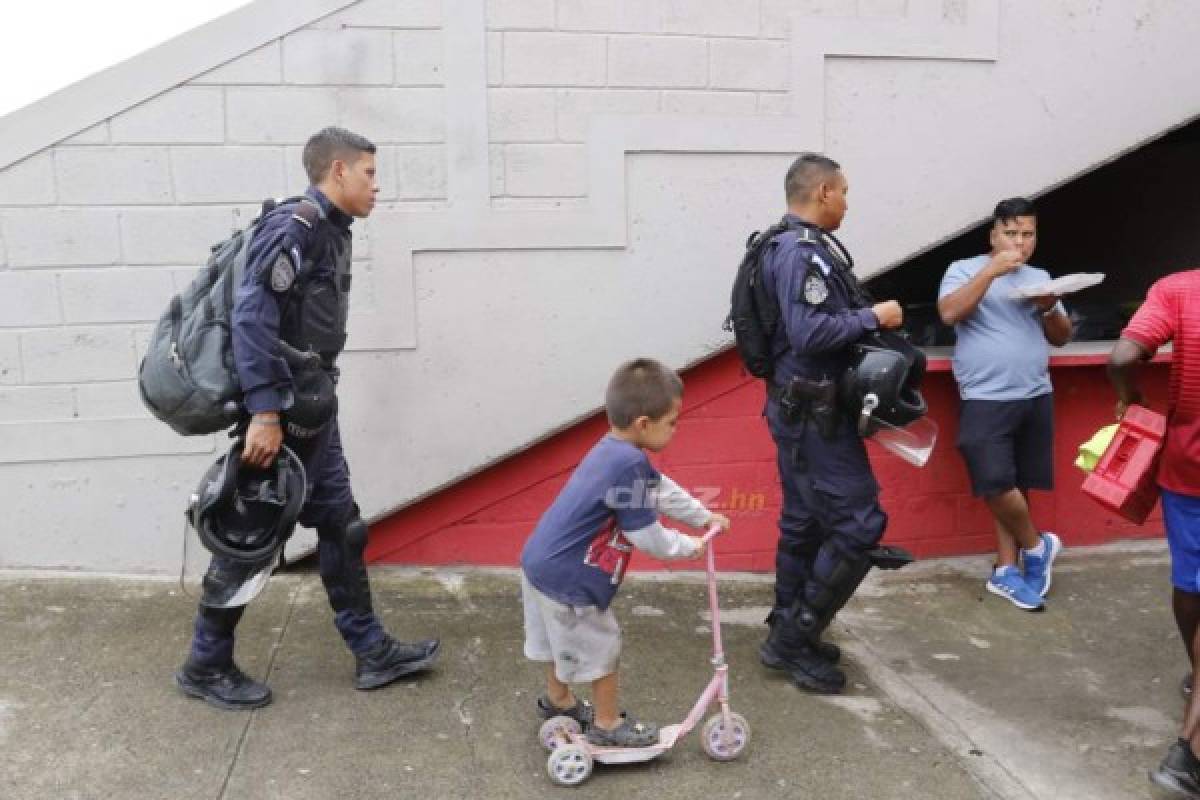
[760,154,902,693]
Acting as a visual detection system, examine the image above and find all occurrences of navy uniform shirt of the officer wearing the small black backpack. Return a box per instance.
[763,215,880,386]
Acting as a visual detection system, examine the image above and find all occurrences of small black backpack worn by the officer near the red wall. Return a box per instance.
[724,219,794,381]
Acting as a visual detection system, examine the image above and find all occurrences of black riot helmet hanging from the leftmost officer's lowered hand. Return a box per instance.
[186,439,306,565]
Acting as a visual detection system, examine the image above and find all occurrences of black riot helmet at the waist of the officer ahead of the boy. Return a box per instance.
[839,331,929,437]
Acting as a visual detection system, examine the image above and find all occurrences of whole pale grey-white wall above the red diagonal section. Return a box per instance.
[0,0,1200,572]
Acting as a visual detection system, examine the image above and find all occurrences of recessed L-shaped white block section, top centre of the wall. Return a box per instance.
[487,0,840,200]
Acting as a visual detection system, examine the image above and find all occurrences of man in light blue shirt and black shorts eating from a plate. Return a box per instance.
[937,198,1072,610]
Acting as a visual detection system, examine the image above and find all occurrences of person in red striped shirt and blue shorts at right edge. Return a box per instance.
[1109,270,1200,799]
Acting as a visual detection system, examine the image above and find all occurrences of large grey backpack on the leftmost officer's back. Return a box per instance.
[138,197,324,437]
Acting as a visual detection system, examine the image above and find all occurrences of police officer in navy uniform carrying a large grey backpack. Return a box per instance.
[175,127,439,709]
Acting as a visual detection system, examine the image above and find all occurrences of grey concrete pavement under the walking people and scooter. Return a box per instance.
[0,542,1186,800]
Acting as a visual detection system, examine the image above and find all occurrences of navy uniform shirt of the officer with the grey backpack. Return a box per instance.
[233,186,354,414]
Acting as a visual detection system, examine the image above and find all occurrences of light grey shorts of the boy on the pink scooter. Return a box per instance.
[521,573,620,684]
